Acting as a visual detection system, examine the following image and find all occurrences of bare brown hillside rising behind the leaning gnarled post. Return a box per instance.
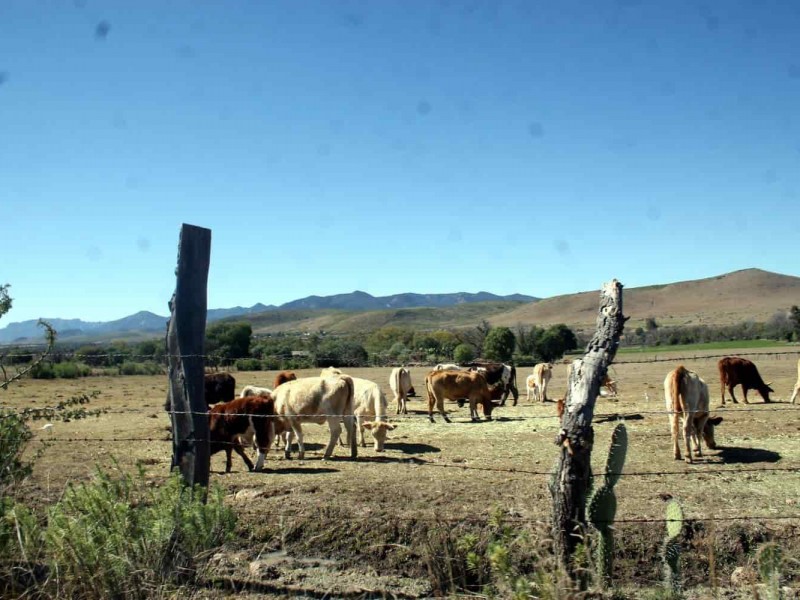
[489,269,800,336]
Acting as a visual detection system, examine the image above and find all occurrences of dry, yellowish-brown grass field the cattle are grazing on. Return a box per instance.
[0,351,800,597]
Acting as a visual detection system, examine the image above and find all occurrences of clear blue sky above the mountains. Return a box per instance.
[0,0,800,326]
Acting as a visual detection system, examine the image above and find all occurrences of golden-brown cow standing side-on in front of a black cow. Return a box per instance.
[425,371,503,423]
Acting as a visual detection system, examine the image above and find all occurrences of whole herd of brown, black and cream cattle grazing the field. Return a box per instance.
[183,357,800,472]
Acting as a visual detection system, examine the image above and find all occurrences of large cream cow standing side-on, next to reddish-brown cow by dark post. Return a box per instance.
[272,375,358,460]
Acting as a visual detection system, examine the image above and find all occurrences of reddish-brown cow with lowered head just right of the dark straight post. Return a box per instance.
[208,394,275,473]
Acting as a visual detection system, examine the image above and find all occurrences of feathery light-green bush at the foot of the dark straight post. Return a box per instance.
[44,471,236,598]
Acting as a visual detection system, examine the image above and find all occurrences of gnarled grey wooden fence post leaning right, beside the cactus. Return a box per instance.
[550,279,627,579]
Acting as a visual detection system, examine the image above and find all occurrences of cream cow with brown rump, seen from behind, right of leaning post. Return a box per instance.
[664,365,722,463]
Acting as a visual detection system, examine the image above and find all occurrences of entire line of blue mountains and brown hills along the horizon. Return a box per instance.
[0,269,800,343]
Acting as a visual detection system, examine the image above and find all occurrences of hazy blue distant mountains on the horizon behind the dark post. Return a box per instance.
[0,291,535,344]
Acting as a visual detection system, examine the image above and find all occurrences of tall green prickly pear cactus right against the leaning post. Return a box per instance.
[588,423,628,585]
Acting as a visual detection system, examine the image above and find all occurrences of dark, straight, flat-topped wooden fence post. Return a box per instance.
[167,223,211,487]
